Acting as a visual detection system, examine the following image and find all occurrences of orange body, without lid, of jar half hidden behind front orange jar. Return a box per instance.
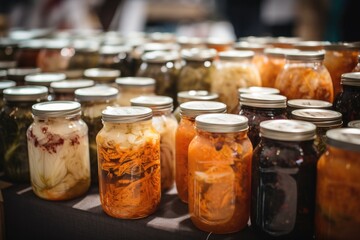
[175,115,196,203]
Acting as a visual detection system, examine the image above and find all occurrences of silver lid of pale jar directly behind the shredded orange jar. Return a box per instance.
[130,96,173,113]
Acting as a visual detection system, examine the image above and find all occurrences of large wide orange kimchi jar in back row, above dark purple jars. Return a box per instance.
[274,51,334,102]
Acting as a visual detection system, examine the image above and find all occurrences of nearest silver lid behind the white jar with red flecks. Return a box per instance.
[50,79,95,93]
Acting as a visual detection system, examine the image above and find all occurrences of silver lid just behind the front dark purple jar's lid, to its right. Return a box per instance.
[291,109,342,127]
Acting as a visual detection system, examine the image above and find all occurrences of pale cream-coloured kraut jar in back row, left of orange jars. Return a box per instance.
[211,51,261,114]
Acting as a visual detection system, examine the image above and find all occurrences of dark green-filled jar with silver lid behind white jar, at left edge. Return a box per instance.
[0,86,48,183]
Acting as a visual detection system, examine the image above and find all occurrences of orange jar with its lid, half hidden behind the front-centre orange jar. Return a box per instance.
[175,101,226,203]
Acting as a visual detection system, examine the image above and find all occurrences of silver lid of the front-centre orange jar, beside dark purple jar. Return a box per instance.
[195,113,248,133]
